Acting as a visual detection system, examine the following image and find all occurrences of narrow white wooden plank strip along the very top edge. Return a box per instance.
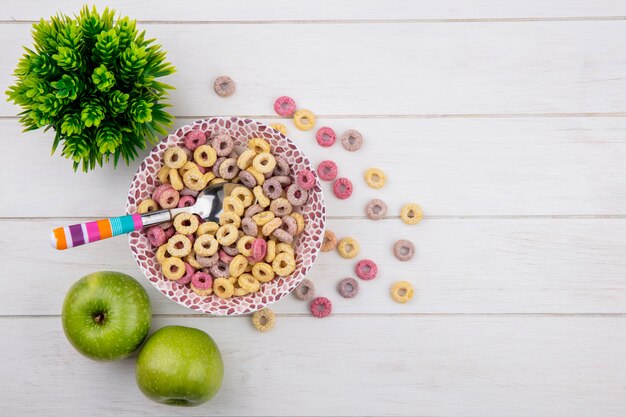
[0,0,626,22]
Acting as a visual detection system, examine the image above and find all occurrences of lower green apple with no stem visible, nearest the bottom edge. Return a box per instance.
[135,326,224,406]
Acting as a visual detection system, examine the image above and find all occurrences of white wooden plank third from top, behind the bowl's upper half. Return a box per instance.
[0,118,626,217]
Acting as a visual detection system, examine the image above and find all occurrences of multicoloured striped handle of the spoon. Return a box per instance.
[50,214,144,250]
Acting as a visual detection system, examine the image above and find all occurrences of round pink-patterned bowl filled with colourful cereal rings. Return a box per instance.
[126,117,326,315]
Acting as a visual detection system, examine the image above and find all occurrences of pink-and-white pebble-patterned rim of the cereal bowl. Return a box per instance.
[126,116,326,316]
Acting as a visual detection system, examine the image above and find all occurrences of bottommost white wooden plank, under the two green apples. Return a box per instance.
[0,317,626,417]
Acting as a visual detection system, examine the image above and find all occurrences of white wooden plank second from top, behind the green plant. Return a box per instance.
[0,21,626,116]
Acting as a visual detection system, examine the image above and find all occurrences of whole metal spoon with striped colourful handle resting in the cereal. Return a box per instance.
[50,182,241,250]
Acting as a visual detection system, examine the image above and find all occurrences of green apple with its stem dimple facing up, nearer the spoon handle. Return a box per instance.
[63,271,152,361]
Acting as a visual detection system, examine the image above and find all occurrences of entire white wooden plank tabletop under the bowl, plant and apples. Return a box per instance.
[0,0,626,417]
